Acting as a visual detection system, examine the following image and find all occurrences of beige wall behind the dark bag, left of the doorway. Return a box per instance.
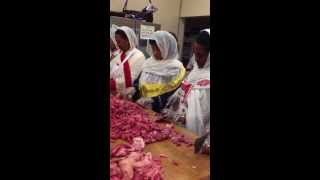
[110,0,181,34]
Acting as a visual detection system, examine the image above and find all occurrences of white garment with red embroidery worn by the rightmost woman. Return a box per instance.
[168,29,210,144]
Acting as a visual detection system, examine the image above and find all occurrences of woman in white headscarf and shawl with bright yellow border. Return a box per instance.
[124,31,186,112]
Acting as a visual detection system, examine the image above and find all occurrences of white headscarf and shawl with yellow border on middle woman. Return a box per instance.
[139,31,185,97]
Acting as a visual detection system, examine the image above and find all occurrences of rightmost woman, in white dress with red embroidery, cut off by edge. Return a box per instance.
[164,29,210,153]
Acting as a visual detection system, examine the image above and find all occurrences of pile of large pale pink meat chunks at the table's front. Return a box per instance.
[110,138,163,180]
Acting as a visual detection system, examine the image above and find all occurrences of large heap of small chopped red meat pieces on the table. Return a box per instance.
[110,96,193,146]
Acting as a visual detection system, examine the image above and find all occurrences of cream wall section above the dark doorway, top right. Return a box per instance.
[180,0,210,17]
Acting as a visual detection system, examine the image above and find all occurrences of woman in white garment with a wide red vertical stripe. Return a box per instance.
[110,26,145,93]
